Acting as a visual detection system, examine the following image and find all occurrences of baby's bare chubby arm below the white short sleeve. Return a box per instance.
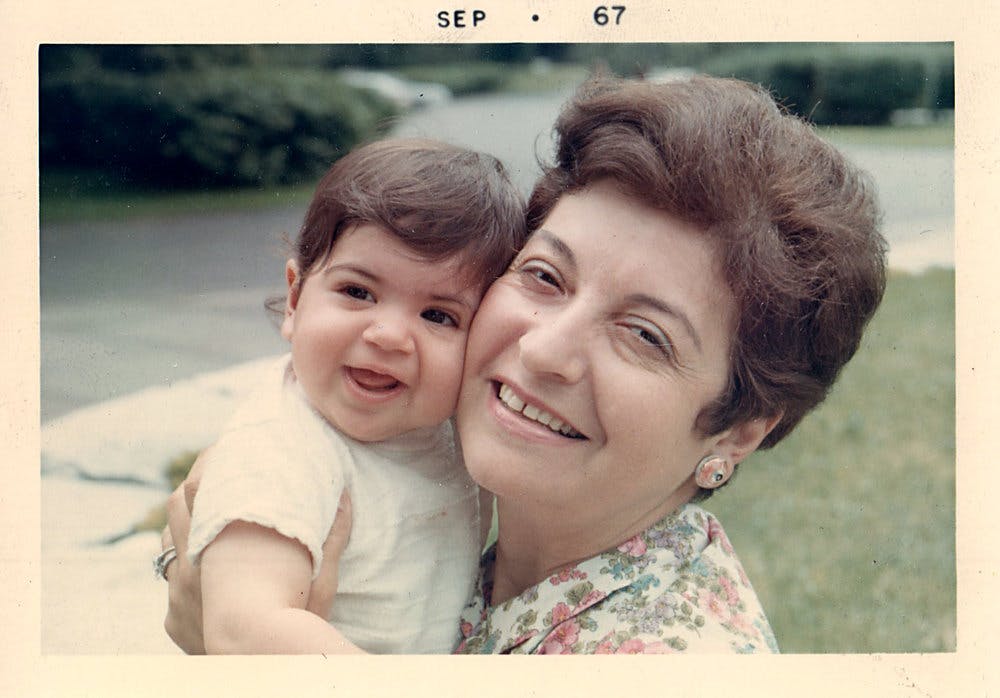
[201,521,362,654]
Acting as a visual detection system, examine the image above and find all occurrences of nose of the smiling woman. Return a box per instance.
[518,307,588,383]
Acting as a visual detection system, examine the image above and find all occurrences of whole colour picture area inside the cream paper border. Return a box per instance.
[37,42,957,655]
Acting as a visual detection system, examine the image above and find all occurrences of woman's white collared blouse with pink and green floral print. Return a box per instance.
[456,504,778,654]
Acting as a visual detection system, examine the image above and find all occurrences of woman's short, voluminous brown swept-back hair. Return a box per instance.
[528,77,886,448]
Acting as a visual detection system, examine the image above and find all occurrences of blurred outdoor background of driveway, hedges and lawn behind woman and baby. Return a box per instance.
[38,43,955,653]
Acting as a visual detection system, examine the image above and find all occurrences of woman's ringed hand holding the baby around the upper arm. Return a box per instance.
[163,450,352,654]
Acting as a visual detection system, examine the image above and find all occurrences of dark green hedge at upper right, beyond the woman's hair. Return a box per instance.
[703,44,954,125]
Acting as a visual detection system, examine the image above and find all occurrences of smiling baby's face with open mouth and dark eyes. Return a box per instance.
[281,223,482,441]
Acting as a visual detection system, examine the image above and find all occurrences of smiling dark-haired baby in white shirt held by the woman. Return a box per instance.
[188,139,526,654]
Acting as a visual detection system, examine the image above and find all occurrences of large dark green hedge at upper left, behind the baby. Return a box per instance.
[39,53,394,187]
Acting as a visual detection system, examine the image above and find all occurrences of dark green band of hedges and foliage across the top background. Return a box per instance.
[39,43,954,188]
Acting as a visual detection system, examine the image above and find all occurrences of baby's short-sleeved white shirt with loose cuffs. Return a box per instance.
[188,356,479,654]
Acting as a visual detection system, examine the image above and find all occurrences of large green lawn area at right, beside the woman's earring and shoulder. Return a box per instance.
[706,270,956,652]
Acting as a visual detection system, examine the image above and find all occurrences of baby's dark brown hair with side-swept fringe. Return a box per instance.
[294,138,527,289]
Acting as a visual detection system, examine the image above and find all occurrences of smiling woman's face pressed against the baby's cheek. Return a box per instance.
[458,183,735,525]
